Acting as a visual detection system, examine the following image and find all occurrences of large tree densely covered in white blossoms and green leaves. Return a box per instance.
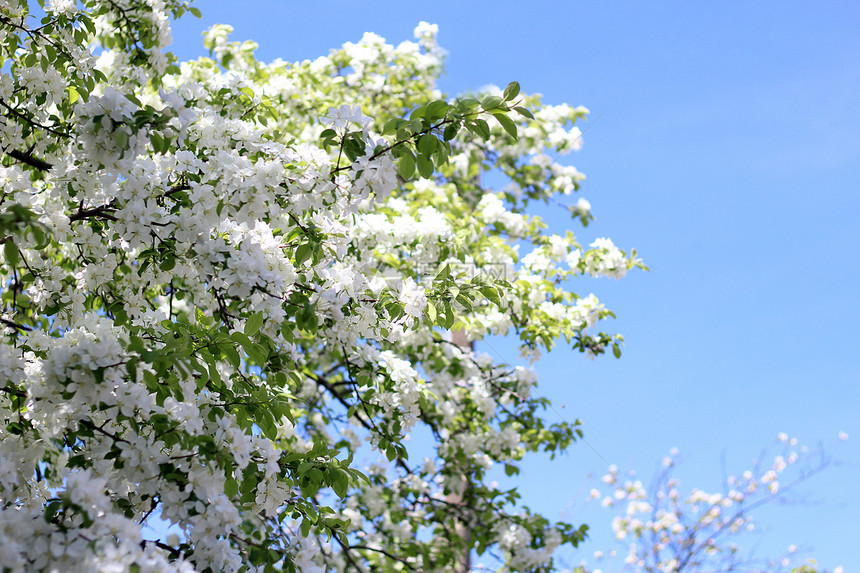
[0,0,641,572]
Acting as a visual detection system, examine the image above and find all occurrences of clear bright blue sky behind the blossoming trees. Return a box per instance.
[174,0,860,572]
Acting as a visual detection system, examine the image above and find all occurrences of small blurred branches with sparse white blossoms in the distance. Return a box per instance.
[577,432,848,573]
